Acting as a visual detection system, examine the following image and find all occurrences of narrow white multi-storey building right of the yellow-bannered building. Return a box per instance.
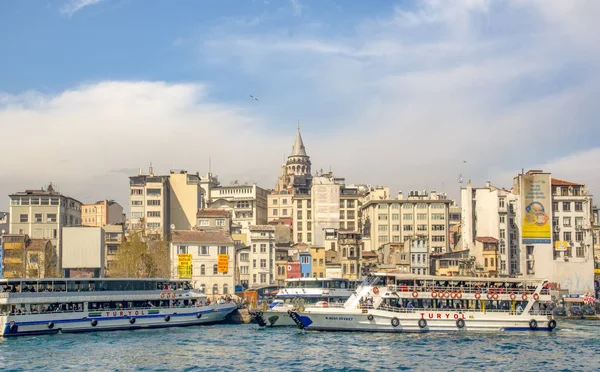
[246,225,276,288]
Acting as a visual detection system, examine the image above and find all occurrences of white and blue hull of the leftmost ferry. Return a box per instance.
[0,304,237,337]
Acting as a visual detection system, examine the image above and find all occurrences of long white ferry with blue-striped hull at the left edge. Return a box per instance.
[0,279,237,337]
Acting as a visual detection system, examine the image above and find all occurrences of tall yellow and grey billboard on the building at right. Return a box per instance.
[521,173,552,244]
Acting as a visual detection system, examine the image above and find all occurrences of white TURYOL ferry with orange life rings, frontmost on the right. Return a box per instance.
[290,273,556,332]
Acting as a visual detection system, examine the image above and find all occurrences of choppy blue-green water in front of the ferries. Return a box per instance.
[0,322,600,372]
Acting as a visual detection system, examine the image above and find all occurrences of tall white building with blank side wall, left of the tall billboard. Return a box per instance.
[461,181,521,276]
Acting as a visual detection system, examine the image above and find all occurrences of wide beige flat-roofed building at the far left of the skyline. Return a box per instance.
[9,184,82,258]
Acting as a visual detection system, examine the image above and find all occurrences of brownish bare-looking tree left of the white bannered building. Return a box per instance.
[109,233,171,278]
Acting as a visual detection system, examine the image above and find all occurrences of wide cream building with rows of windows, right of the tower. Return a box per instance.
[361,191,453,253]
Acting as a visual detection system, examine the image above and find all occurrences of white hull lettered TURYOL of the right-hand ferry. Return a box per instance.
[291,309,556,333]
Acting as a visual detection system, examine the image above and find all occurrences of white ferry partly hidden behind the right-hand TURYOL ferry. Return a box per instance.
[254,278,358,327]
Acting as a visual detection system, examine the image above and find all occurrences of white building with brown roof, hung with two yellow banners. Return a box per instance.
[170,230,235,295]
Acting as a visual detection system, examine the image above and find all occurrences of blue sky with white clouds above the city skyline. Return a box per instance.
[0,0,600,210]
